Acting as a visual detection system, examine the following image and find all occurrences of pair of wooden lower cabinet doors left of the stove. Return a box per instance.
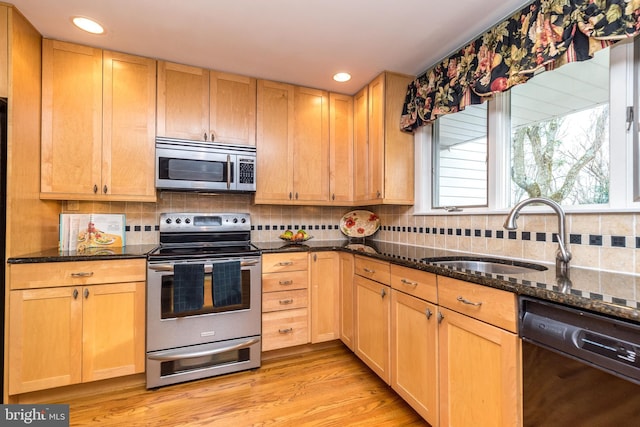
[9,282,145,395]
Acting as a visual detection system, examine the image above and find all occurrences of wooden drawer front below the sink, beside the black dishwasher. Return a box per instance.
[438,276,517,332]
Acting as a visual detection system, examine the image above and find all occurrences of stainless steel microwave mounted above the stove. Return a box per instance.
[156,137,256,192]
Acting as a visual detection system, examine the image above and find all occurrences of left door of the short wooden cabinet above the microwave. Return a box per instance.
[157,61,210,141]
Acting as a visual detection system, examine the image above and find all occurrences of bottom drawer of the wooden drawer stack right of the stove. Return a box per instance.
[262,308,309,351]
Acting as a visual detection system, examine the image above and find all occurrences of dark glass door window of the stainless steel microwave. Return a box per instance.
[158,157,233,182]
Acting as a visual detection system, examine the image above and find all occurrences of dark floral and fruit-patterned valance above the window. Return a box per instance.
[400,0,640,131]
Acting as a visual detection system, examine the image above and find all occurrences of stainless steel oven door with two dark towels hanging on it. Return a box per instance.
[147,257,262,352]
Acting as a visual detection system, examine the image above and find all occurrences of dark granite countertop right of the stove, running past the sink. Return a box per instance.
[252,239,640,323]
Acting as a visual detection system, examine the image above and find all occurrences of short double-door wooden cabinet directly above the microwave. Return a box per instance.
[158,61,256,145]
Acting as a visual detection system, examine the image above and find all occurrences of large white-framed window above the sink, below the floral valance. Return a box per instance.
[415,40,640,213]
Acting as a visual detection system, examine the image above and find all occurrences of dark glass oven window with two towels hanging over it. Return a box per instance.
[160,263,251,319]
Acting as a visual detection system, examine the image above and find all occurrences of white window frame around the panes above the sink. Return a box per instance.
[414,37,640,215]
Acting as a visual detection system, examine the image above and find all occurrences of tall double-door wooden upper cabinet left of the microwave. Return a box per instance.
[40,39,155,201]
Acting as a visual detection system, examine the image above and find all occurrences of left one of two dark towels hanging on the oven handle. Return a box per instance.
[173,264,204,314]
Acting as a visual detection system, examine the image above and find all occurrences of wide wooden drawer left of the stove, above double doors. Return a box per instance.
[10,258,147,289]
